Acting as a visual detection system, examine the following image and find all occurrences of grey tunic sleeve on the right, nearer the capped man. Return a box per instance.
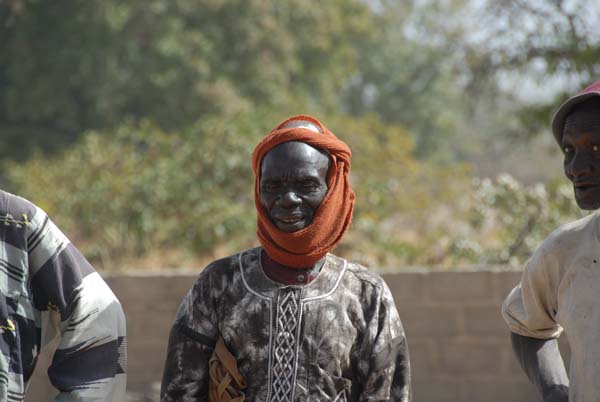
[359,283,412,402]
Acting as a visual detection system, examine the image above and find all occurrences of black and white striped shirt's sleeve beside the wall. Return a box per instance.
[27,209,126,402]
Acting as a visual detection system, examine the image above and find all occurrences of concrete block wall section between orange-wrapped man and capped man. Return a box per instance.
[385,268,539,402]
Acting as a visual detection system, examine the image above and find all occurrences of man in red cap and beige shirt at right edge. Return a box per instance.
[502,82,600,402]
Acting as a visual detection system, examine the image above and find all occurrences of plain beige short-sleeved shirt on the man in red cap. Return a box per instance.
[502,213,600,402]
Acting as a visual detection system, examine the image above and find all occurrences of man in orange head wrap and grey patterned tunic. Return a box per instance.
[161,116,411,402]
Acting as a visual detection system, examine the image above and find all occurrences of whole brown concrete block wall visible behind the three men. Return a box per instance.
[26,267,568,402]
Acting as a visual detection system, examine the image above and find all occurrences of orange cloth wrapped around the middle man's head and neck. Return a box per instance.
[252,115,355,268]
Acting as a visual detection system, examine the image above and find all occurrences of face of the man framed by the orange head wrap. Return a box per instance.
[259,141,329,233]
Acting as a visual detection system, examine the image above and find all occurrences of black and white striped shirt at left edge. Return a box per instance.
[0,190,126,402]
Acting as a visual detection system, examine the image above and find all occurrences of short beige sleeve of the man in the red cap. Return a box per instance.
[502,247,563,339]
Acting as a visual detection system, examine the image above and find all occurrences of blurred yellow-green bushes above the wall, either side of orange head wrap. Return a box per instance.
[5,111,468,269]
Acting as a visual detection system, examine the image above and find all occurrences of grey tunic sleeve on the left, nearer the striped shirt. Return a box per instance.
[160,274,218,402]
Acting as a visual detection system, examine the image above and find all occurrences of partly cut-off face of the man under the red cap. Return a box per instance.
[562,98,600,210]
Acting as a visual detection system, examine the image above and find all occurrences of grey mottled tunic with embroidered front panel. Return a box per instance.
[161,247,411,402]
